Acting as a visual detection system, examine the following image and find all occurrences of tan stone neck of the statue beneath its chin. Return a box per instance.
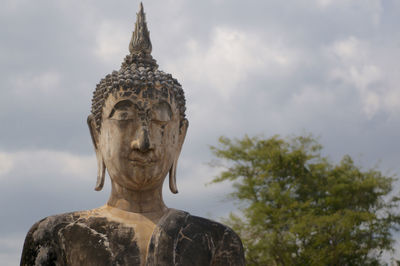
[107,181,168,213]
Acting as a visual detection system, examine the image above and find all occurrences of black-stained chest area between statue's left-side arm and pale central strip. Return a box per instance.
[58,219,142,266]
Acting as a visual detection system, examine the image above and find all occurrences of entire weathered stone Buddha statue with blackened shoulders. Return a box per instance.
[21,4,244,266]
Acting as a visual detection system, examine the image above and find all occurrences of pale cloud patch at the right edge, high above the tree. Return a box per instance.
[328,36,400,118]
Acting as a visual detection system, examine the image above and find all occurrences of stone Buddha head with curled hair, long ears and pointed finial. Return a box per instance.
[88,4,188,193]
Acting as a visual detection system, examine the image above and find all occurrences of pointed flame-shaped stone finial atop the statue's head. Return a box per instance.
[129,2,151,55]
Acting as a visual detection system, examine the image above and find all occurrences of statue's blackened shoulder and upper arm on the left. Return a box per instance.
[21,212,85,265]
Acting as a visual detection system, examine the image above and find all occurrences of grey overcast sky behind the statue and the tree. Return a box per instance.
[0,0,400,265]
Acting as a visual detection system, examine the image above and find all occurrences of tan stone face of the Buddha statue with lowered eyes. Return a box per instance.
[96,90,186,190]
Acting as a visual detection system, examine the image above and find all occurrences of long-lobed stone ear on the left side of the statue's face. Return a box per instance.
[87,115,106,191]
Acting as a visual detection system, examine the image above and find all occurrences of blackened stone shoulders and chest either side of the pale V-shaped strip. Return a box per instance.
[21,208,244,266]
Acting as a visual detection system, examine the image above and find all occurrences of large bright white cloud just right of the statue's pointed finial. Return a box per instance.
[168,27,298,100]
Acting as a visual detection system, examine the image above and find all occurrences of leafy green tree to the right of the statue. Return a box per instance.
[211,136,400,265]
